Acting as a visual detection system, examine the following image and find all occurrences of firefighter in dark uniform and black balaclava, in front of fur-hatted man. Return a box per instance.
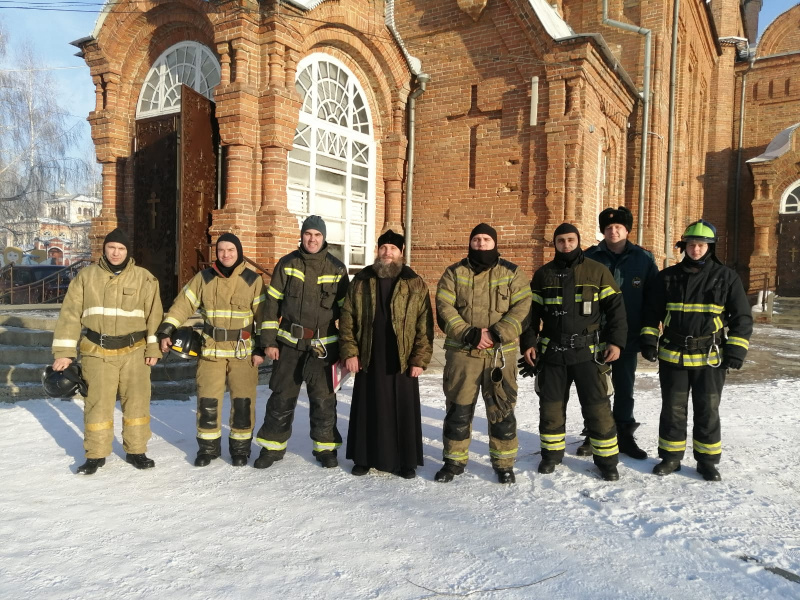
[521,223,628,481]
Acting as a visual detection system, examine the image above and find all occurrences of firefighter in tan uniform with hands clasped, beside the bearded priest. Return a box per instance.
[436,223,531,483]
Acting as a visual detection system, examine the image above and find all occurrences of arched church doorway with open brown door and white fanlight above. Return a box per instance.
[133,42,220,306]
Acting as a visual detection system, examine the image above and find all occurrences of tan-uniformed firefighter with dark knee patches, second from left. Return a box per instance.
[158,233,264,467]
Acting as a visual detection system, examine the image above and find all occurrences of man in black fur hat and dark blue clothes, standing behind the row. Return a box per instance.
[577,206,658,460]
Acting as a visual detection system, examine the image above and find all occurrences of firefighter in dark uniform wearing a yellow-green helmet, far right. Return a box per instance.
[641,220,753,481]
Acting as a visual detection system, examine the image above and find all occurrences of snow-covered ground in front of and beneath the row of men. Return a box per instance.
[0,333,800,600]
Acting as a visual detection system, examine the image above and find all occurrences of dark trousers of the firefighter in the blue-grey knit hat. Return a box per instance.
[256,345,342,457]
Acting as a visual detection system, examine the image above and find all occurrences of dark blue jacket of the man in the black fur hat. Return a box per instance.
[584,240,658,353]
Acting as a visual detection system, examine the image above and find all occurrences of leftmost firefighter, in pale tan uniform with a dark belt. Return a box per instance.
[53,229,163,475]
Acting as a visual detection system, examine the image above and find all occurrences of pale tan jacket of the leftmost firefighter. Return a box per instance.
[53,258,164,358]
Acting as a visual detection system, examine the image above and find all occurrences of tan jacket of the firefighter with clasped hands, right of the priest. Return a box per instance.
[436,258,531,356]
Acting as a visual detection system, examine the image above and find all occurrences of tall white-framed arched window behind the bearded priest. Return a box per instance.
[287,53,375,267]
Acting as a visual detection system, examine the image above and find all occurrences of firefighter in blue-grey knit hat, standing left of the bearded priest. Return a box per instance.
[253,215,350,469]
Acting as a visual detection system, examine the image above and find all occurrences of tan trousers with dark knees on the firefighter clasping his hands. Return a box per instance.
[442,348,517,469]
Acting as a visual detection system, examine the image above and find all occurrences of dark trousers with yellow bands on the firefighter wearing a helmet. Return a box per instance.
[658,360,725,464]
